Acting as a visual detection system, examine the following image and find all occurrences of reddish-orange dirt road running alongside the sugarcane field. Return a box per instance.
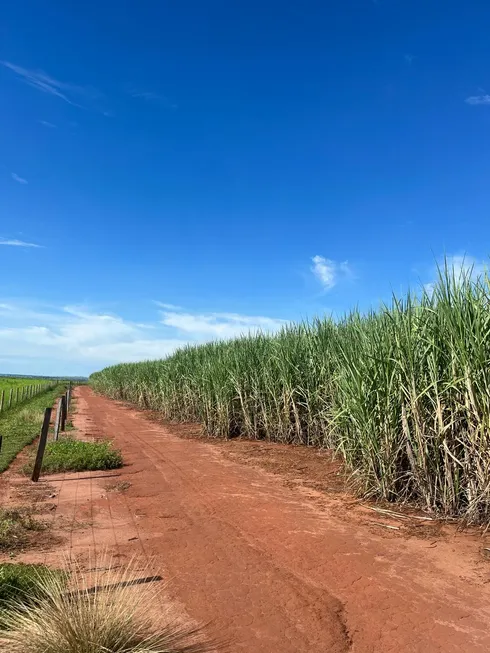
[71,388,490,653]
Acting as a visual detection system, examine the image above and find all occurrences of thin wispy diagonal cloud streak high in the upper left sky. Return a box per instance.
[0,61,104,112]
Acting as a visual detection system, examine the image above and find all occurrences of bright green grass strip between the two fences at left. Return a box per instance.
[0,384,64,472]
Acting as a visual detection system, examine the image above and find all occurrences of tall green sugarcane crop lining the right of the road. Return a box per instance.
[90,267,490,523]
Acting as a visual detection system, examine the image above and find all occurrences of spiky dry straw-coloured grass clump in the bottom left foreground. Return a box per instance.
[0,563,215,653]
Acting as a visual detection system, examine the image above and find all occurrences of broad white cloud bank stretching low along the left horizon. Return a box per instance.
[0,300,283,375]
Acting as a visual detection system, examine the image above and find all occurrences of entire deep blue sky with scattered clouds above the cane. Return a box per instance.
[0,0,490,374]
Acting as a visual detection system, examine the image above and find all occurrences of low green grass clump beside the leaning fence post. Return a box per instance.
[25,437,123,474]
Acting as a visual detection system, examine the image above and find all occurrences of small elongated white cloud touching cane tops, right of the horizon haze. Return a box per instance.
[161,311,286,338]
